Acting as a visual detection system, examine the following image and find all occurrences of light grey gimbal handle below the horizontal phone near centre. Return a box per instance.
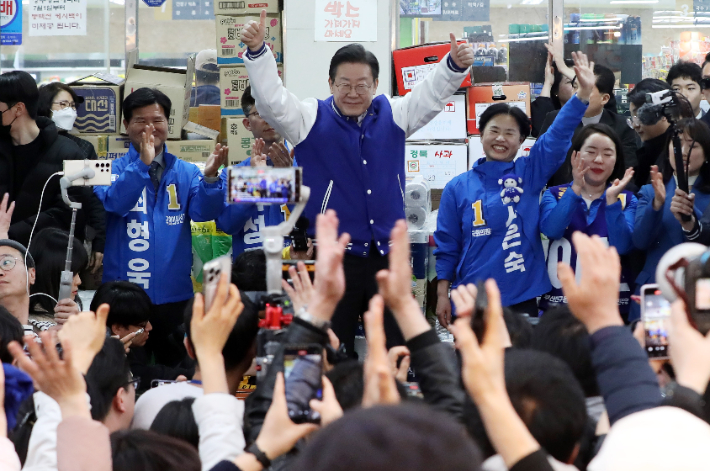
[261,186,311,294]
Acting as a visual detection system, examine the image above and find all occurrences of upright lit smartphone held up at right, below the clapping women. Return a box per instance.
[641,285,671,358]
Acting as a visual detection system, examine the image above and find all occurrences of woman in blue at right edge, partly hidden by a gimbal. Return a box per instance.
[629,118,710,321]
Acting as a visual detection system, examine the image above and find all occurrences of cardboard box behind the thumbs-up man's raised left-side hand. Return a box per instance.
[215,15,283,65]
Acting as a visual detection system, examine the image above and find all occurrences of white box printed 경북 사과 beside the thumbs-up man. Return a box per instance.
[404,143,468,190]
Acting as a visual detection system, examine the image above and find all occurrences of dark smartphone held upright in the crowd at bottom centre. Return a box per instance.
[284,345,323,424]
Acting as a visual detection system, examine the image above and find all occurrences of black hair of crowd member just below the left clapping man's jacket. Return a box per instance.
[90,281,152,328]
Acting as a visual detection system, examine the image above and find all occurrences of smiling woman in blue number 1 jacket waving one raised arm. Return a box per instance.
[434,53,595,326]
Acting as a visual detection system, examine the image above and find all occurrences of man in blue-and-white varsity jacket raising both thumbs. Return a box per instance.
[242,11,473,355]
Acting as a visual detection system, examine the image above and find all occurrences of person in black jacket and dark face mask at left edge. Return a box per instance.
[0,71,90,249]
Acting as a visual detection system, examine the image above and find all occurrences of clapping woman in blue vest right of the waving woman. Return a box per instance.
[540,124,637,313]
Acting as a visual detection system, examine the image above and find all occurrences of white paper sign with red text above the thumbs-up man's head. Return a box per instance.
[315,0,377,43]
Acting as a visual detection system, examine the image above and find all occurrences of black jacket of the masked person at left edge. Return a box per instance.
[0,116,91,245]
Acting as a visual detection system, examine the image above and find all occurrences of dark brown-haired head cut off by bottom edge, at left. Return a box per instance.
[111,430,202,471]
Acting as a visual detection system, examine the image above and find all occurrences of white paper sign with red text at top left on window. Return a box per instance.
[28,0,87,36]
